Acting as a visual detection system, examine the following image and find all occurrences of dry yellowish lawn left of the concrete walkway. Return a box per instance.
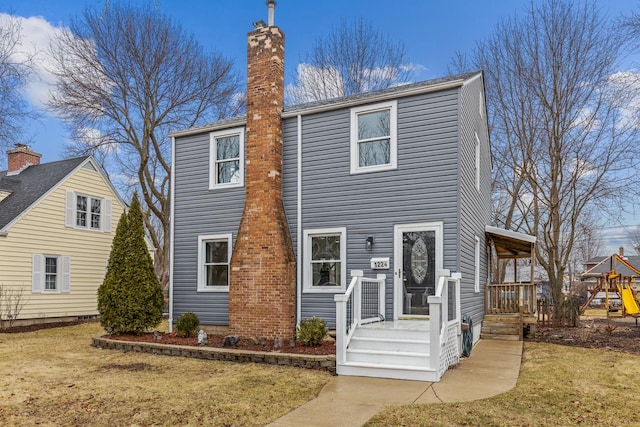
[0,323,331,426]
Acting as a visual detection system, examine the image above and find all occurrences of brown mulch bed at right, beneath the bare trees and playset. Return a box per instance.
[526,318,640,355]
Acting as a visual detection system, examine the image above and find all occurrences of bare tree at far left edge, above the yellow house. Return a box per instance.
[0,14,33,163]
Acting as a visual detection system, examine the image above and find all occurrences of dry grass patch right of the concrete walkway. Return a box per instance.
[367,343,640,426]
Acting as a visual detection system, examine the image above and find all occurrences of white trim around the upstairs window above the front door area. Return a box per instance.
[351,100,398,174]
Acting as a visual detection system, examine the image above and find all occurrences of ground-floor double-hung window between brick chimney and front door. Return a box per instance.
[303,227,347,292]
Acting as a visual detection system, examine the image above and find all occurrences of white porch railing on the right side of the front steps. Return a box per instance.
[428,270,461,380]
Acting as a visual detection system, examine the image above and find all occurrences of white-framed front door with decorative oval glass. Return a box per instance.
[394,221,443,319]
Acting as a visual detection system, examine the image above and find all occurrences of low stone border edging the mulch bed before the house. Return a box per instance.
[91,336,336,375]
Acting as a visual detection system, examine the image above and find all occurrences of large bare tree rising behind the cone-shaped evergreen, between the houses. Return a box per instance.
[51,2,238,290]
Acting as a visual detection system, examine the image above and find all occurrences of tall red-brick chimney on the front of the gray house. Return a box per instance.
[229,0,296,340]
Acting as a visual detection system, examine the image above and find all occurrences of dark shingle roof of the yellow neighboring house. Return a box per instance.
[0,156,89,230]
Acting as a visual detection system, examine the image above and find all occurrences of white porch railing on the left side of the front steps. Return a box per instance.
[334,270,386,363]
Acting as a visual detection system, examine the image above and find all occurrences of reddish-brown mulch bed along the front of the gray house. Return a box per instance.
[104,332,336,356]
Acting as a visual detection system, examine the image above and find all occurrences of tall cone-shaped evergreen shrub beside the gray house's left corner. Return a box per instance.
[98,194,164,335]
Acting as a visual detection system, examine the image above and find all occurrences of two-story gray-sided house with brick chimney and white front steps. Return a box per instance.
[169,2,535,381]
